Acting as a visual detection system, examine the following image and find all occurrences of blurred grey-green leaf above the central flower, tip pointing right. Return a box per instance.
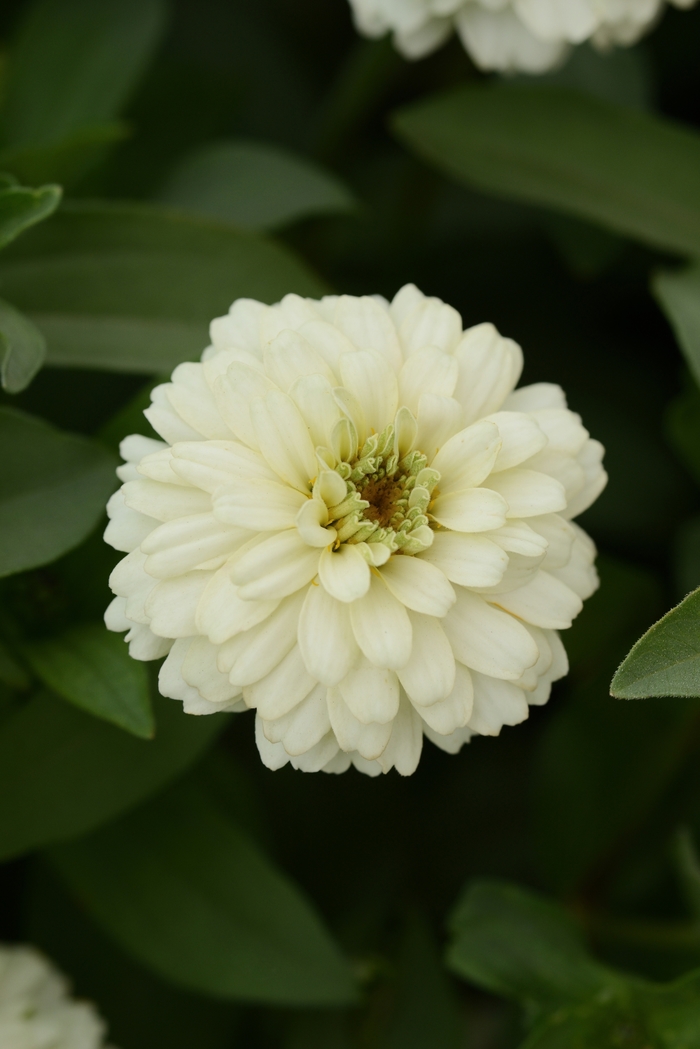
[160,140,356,230]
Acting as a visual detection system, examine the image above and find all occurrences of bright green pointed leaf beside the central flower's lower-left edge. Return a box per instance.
[23,623,155,740]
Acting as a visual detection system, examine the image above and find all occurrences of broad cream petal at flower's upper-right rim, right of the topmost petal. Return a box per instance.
[454,324,523,425]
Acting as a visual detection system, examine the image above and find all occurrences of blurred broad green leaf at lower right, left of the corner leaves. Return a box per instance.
[447,881,614,1007]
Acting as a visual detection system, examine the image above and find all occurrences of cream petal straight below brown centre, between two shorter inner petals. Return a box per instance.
[351,573,411,670]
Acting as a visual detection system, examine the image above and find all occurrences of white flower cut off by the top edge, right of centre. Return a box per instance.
[349,0,697,73]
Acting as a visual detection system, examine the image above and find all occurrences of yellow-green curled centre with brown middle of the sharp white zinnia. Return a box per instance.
[328,426,440,554]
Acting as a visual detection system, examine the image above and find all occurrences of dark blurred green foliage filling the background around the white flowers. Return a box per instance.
[0,0,700,1049]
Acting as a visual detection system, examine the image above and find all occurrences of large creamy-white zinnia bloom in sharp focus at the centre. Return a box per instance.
[105,284,606,775]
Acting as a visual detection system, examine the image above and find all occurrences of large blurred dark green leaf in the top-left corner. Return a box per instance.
[5,0,166,146]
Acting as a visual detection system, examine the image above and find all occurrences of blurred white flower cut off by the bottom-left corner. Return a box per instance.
[0,946,113,1049]
